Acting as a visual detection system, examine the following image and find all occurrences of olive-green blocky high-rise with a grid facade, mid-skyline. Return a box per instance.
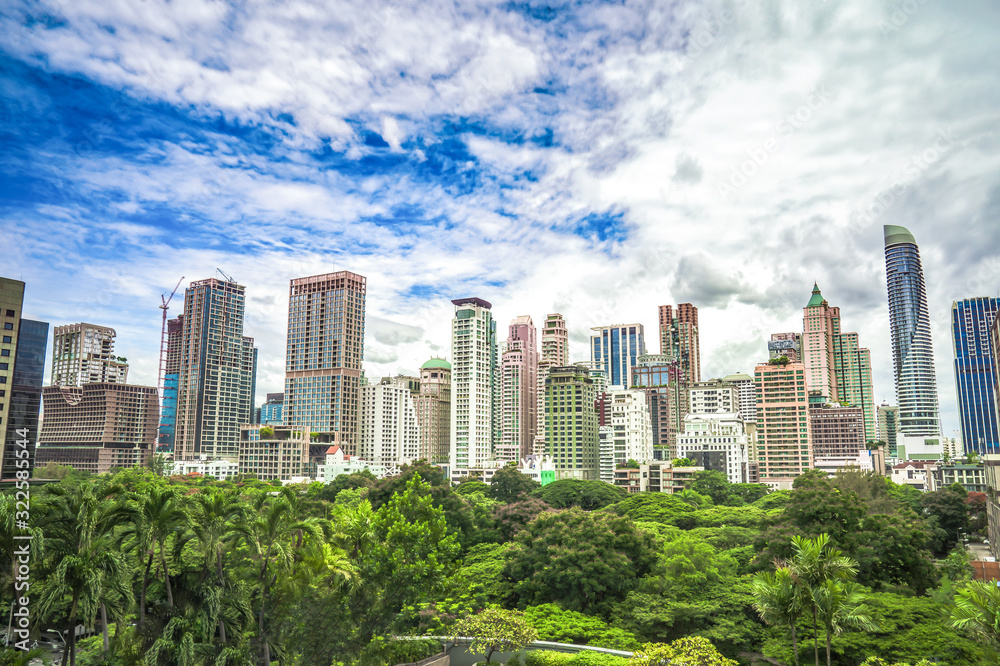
[545,365,599,479]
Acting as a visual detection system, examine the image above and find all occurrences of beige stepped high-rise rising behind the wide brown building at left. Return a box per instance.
[52,324,128,386]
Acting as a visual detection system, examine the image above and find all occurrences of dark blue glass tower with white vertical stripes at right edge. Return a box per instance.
[951,297,1000,455]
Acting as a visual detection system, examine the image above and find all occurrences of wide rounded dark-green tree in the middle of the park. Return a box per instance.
[504,508,655,613]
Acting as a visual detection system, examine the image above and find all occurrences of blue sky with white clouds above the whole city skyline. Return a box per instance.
[0,0,1000,434]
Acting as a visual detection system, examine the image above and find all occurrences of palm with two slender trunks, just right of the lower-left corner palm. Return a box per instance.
[116,486,191,631]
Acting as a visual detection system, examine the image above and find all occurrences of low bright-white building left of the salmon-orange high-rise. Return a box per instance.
[677,412,750,483]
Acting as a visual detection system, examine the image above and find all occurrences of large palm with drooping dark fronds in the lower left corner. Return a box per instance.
[39,486,132,666]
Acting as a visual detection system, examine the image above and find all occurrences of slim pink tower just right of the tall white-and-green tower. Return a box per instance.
[496,315,539,462]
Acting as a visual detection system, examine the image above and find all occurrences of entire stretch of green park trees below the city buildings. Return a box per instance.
[0,462,1000,666]
